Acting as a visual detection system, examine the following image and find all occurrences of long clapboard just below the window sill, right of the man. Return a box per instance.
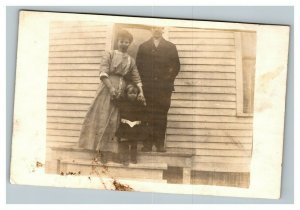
[168,120,252,130]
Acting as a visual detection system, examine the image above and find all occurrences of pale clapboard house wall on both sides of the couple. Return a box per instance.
[47,22,252,175]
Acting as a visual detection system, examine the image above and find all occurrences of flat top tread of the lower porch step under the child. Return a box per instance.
[60,159,168,170]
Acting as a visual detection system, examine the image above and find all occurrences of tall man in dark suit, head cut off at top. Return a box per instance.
[136,27,180,152]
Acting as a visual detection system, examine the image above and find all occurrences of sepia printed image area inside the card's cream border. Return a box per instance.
[46,21,256,188]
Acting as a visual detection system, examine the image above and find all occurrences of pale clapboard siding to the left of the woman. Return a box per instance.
[47,21,111,147]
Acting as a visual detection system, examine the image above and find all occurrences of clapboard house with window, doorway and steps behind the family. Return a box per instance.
[46,22,256,187]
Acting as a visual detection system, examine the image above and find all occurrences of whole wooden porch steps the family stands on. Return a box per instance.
[46,145,192,184]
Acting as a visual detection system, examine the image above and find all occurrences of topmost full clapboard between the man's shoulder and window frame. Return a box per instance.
[169,30,234,39]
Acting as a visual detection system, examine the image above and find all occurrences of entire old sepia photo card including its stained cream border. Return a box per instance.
[11,11,289,198]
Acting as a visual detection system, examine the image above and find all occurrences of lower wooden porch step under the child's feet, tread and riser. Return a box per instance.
[58,159,168,180]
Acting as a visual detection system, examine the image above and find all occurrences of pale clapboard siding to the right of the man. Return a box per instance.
[166,28,252,172]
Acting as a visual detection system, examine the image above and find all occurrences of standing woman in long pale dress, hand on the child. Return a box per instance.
[79,30,145,163]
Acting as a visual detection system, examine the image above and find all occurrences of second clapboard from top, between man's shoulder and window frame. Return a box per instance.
[170,37,234,46]
